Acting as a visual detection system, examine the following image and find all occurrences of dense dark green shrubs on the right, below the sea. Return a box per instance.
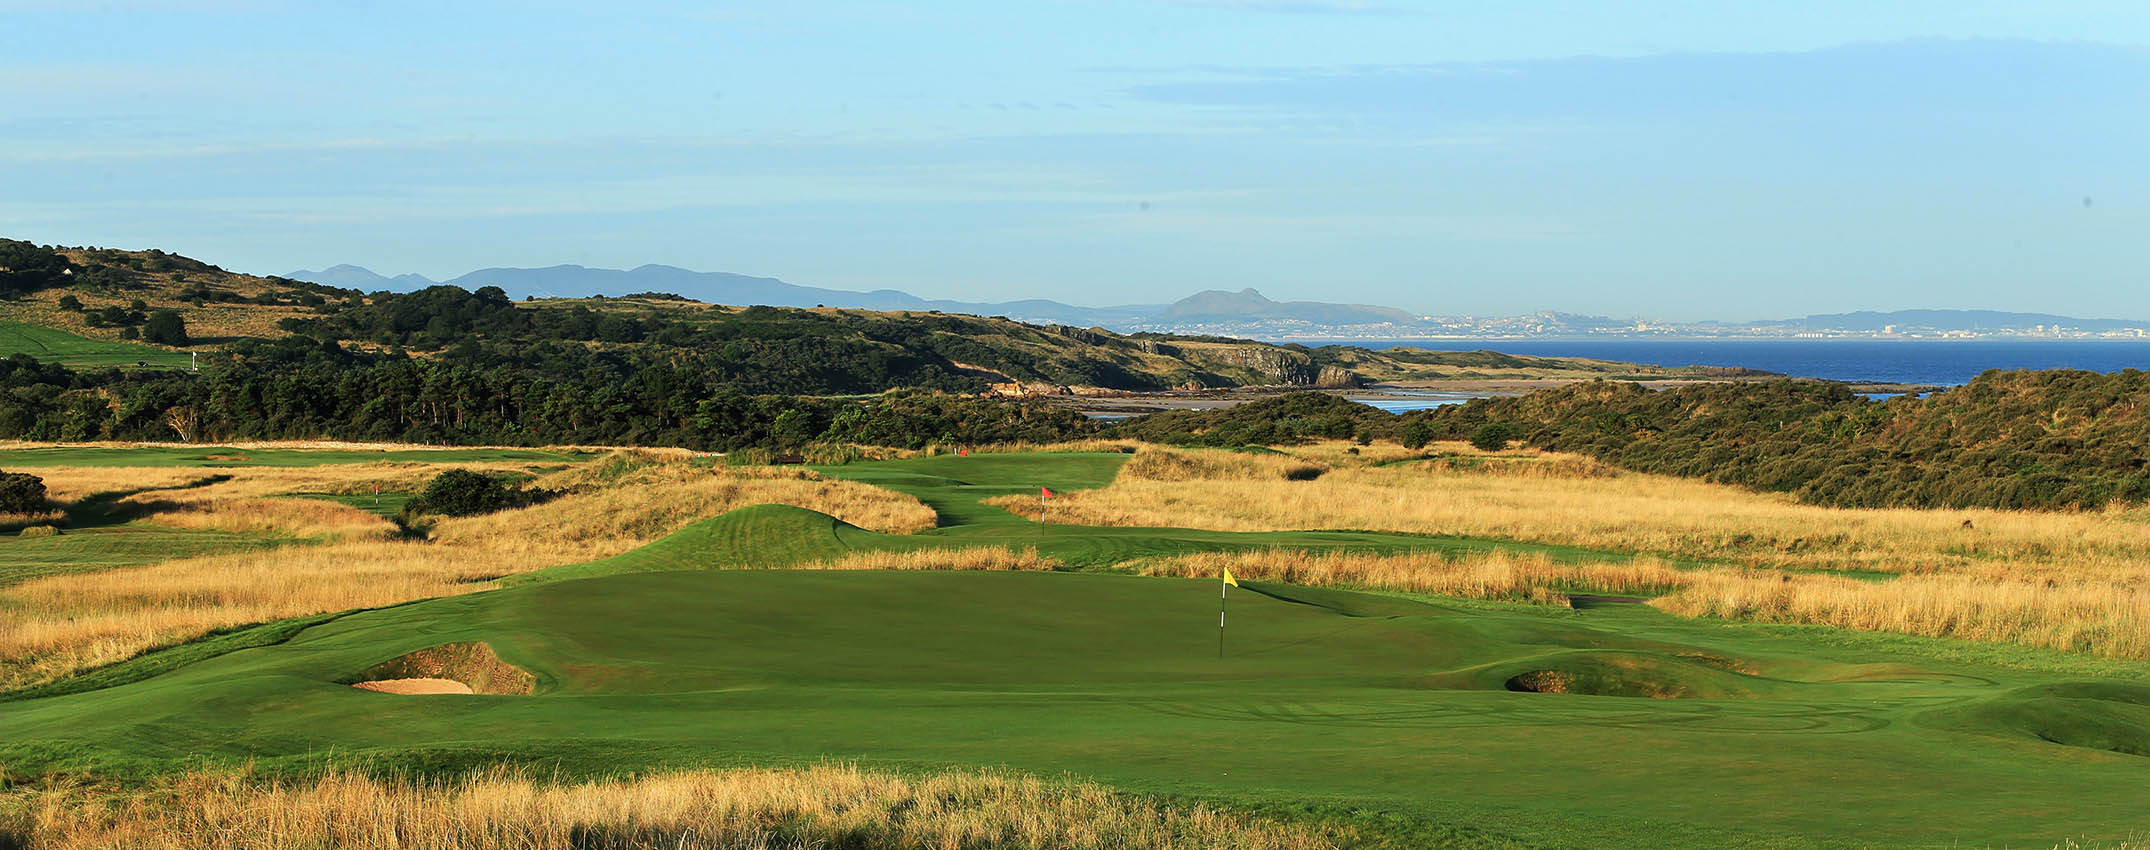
[1406,370,2150,508]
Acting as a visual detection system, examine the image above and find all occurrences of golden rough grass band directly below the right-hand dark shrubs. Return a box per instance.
[1043,445,2150,579]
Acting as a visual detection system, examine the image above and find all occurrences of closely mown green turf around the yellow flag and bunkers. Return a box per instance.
[0,456,2150,848]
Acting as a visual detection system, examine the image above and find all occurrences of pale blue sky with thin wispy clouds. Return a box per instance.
[0,0,2150,321]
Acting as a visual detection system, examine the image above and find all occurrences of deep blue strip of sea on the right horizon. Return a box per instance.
[1344,340,2150,385]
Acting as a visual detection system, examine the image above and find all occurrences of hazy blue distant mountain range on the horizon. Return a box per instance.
[284,265,1417,329]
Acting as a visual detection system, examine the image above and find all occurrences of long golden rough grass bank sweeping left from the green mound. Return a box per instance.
[0,461,933,691]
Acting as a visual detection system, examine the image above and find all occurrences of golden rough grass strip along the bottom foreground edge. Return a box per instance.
[0,766,1333,850]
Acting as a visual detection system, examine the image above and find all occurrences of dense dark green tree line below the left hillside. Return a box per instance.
[0,338,1094,450]
